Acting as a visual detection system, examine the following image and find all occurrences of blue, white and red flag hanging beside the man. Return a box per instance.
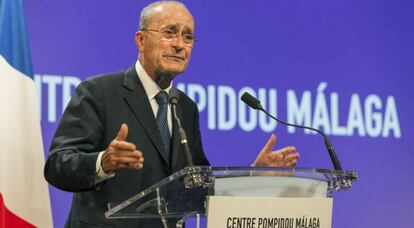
[0,0,53,228]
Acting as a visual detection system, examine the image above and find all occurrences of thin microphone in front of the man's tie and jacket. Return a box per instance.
[169,88,194,166]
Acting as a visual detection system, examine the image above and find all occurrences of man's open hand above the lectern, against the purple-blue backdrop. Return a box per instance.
[253,134,299,167]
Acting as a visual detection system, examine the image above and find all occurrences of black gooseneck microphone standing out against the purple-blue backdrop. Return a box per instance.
[241,92,342,171]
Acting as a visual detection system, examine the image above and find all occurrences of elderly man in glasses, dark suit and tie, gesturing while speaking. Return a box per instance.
[44,1,299,228]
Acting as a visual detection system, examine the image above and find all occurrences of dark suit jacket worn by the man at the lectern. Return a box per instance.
[44,66,209,228]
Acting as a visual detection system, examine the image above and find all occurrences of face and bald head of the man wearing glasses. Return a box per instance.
[136,4,194,78]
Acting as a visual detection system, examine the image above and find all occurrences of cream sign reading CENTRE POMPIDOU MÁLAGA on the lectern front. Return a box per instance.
[207,196,333,228]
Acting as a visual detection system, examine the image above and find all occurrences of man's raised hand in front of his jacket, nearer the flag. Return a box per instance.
[101,123,144,174]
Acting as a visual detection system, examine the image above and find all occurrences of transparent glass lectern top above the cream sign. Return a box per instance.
[105,166,358,227]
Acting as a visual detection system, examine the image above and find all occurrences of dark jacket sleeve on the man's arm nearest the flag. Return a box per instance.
[44,81,105,192]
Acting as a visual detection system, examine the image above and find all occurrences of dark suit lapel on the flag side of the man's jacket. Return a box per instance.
[123,65,170,166]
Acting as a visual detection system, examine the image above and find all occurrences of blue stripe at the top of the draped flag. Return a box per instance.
[0,0,33,78]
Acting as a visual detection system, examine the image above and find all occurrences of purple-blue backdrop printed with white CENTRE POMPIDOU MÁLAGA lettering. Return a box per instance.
[24,0,414,228]
